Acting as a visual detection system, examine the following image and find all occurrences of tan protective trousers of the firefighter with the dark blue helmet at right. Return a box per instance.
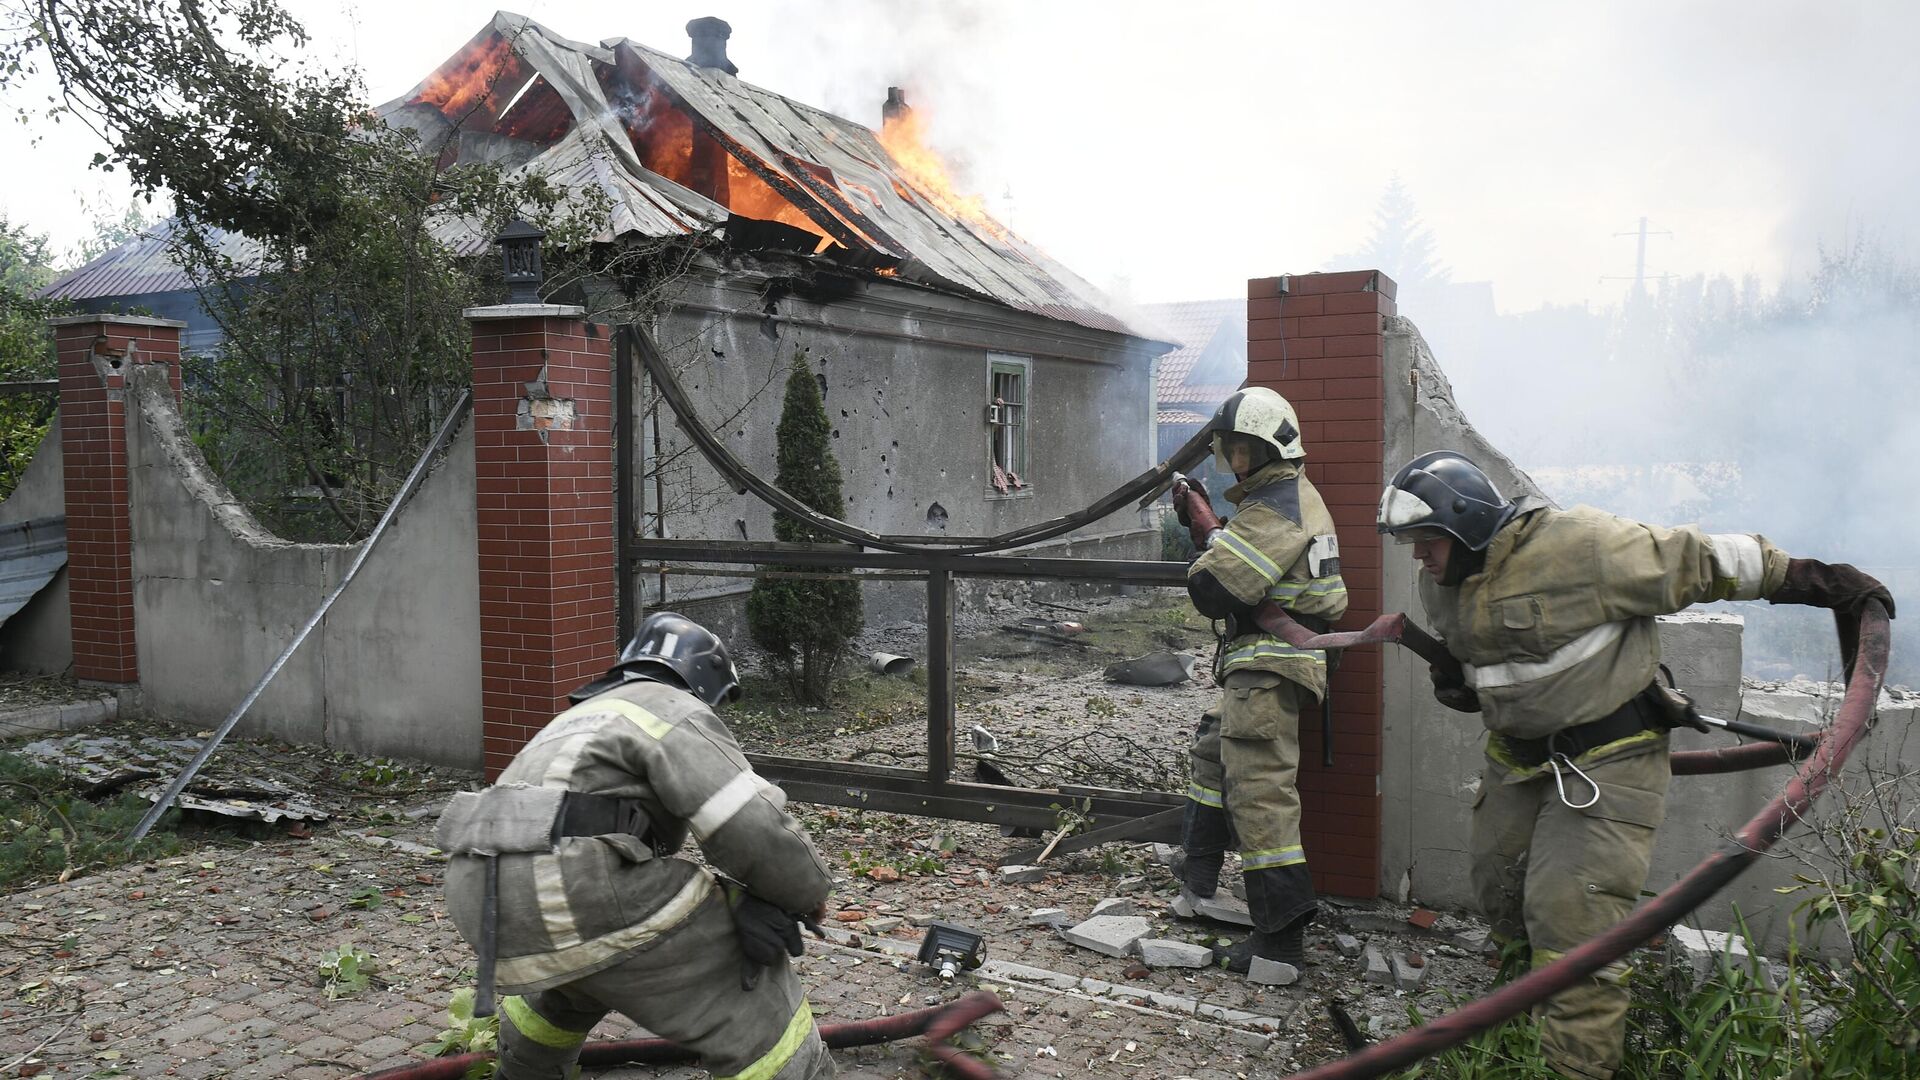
[1473,742,1672,1080]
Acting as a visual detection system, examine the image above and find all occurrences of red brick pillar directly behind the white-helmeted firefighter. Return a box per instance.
[1246,271,1396,896]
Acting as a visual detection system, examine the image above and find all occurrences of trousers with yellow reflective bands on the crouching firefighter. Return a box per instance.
[497,890,833,1080]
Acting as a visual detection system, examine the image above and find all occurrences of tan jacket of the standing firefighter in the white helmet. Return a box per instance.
[1187,461,1346,698]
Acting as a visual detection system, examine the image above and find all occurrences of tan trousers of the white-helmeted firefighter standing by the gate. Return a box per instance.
[1183,671,1315,932]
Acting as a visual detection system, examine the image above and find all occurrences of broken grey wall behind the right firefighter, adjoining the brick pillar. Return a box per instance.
[1380,317,1889,949]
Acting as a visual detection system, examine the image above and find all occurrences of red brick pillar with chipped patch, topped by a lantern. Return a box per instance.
[467,304,616,778]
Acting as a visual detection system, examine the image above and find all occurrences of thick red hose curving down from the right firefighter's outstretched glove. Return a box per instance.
[1294,601,1891,1080]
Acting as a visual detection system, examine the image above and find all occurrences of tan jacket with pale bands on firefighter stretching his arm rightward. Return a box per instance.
[1421,500,1788,738]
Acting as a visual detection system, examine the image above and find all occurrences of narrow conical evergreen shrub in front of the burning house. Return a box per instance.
[747,352,864,705]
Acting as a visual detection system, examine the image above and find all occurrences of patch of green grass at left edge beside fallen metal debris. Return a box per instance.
[0,753,180,890]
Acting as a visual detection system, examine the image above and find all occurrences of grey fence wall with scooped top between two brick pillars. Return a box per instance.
[127,369,480,769]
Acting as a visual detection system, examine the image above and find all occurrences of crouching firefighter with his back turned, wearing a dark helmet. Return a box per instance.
[438,613,833,1080]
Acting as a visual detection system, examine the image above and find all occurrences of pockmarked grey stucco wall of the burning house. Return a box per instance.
[636,263,1160,623]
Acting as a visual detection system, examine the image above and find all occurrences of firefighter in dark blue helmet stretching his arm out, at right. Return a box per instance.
[1379,450,1893,1080]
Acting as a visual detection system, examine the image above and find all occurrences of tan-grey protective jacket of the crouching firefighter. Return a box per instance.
[440,682,831,995]
